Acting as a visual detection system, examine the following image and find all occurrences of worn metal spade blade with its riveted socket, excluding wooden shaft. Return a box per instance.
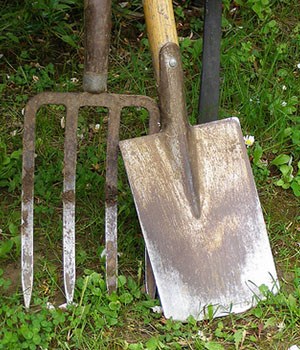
[120,44,278,320]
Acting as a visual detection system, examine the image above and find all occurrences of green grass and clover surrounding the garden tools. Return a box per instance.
[0,0,300,350]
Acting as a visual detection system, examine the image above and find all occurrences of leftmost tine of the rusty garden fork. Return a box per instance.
[21,103,37,309]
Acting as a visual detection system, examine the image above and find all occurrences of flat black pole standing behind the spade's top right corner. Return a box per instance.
[198,0,222,123]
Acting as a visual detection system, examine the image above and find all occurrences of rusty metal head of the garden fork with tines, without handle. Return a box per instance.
[21,92,159,308]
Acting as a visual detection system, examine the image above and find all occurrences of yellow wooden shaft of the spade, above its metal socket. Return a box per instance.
[143,0,178,82]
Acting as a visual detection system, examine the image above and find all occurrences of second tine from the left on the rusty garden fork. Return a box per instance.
[63,106,78,304]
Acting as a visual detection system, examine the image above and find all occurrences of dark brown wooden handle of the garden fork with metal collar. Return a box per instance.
[83,0,111,93]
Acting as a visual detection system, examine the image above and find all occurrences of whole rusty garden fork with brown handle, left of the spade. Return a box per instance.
[21,0,159,308]
